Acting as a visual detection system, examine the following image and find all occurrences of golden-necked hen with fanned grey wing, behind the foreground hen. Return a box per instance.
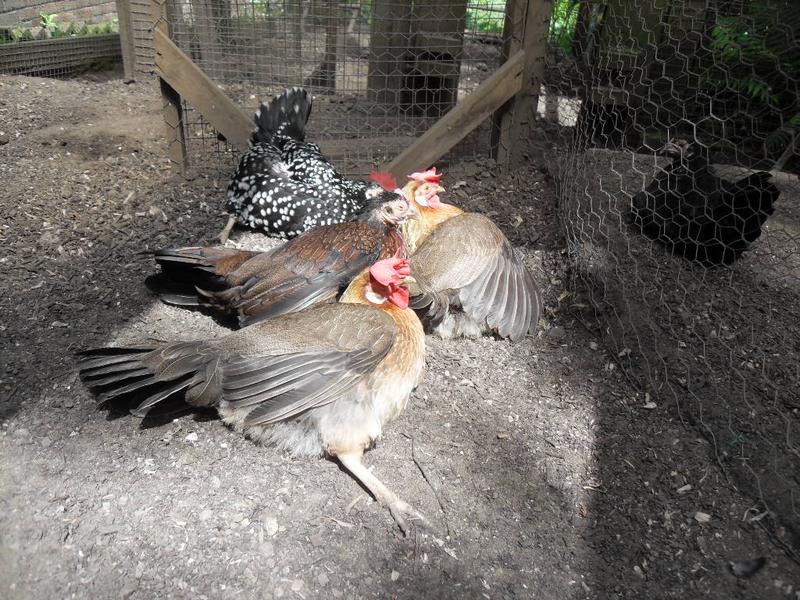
[390,169,541,341]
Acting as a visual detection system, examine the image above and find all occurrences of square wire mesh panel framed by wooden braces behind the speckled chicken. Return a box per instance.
[158,0,505,174]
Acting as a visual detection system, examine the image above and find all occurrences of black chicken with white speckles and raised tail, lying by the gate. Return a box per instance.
[220,88,390,242]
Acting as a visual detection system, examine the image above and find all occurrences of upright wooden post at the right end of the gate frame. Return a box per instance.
[492,0,551,166]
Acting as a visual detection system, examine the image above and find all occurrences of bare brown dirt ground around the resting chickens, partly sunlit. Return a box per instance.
[0,76,800,600]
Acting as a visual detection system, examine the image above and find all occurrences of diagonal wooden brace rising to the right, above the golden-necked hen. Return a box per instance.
[385,50,525,178]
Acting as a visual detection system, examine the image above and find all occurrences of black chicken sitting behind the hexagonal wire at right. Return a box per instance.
[626,140,780,266]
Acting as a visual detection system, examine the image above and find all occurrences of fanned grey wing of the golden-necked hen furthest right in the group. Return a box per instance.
[411,213,541,340]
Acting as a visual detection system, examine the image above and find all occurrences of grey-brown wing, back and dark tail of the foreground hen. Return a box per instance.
[79,304,396,426]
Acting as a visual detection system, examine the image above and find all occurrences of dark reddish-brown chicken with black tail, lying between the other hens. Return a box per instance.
[150,184,419,326]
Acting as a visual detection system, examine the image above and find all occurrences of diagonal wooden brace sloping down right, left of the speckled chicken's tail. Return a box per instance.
[153,29,254,151]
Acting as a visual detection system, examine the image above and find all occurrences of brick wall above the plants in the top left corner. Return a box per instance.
[0,0,117,27]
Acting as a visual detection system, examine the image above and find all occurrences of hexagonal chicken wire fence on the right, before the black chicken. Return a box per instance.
[540,0,800,558]
